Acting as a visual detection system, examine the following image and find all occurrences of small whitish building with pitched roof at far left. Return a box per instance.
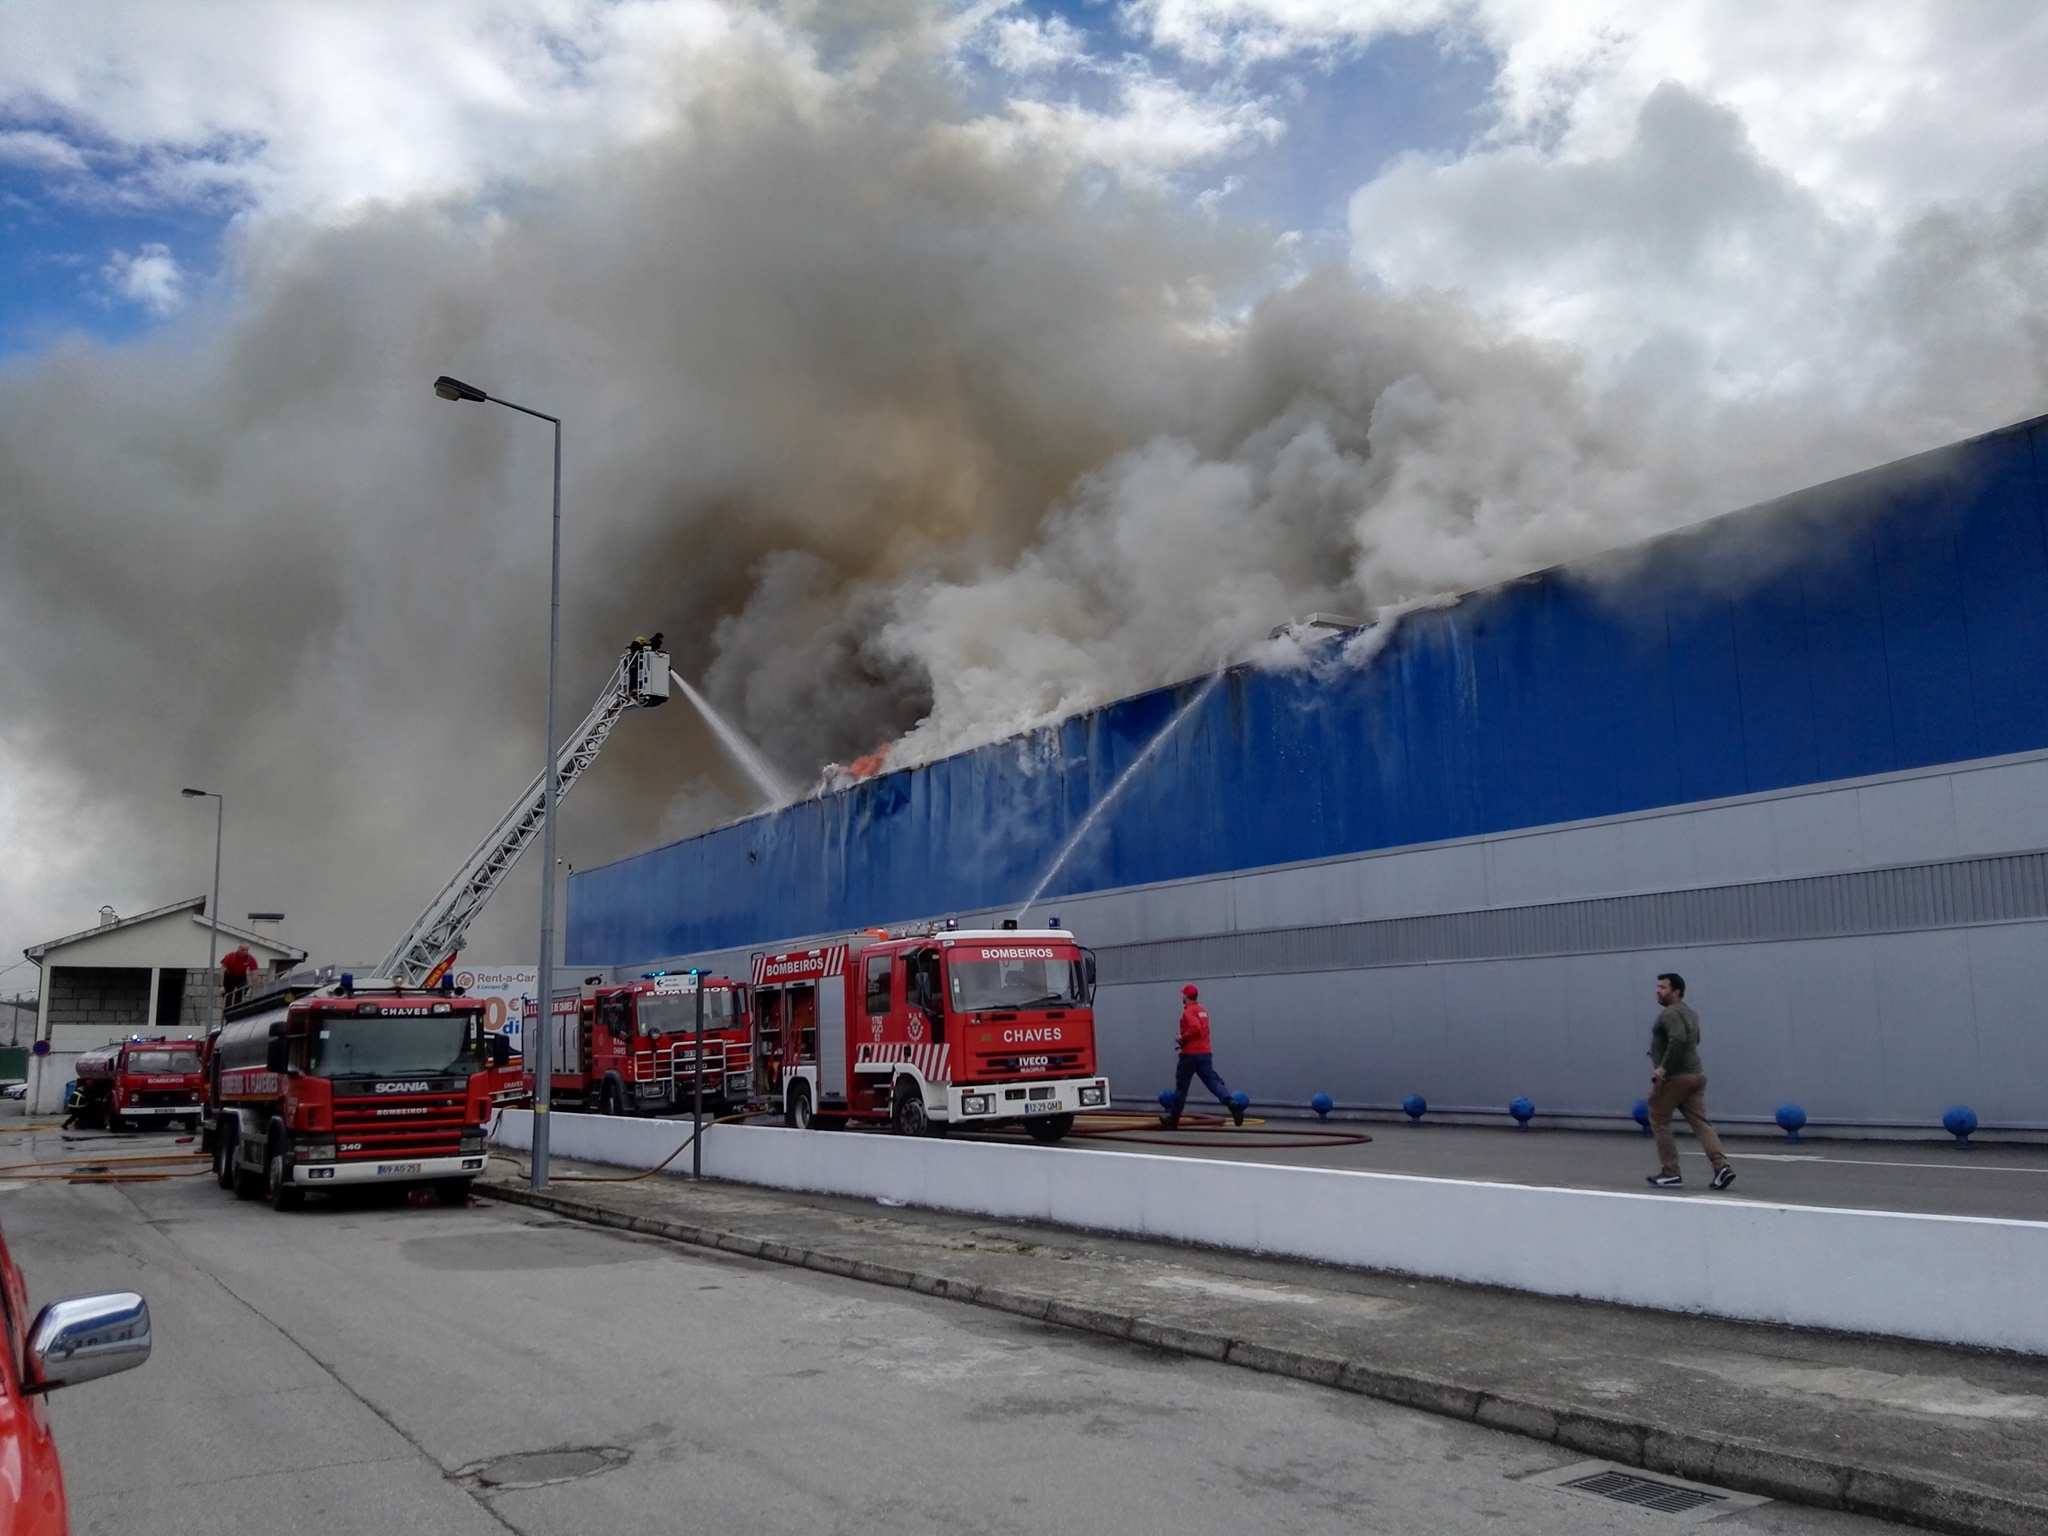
[23,897,305,1112]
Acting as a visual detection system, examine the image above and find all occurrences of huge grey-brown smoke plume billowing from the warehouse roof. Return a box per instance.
[0,6,2048,974]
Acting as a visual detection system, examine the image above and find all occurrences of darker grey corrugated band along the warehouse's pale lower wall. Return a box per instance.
[1098,852,2048,985]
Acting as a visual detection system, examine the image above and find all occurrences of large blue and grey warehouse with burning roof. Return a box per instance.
[567,418,2048,1130]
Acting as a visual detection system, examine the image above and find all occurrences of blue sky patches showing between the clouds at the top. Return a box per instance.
[0,0,1497,356]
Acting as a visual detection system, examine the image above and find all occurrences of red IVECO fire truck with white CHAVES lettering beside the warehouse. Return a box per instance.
[754,926,1110,1143]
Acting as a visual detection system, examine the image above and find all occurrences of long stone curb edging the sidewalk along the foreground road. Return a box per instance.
[475,1184,2048,1536]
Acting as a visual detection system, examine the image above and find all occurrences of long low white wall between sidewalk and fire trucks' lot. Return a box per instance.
[498,1110,2048,1354]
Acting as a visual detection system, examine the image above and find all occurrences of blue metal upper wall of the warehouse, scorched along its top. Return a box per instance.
[567,418,2048,965]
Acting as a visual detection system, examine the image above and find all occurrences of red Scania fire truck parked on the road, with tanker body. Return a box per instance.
[213,975,510,1210]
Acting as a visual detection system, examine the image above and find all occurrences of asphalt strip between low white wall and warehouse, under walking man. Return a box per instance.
[942,1106,2048,1221]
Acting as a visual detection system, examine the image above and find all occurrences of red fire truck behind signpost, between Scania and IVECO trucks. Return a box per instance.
[549,971,754,1114]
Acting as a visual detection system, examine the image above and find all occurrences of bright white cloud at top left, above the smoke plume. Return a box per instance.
[0,0,809,219]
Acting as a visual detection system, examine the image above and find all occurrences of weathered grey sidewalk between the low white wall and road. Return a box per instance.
[477,1159,2048,1536]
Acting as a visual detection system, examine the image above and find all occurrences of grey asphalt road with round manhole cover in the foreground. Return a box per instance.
[0,1135,1892,1536]
